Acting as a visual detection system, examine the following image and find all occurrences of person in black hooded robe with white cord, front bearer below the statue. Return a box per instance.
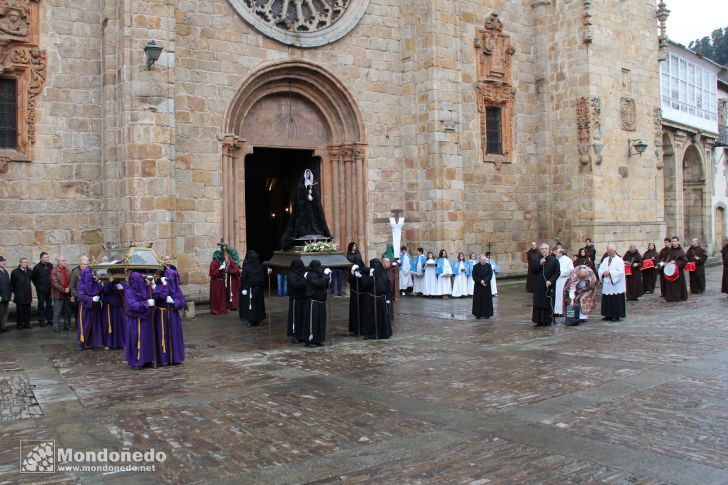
[303,259,331,347]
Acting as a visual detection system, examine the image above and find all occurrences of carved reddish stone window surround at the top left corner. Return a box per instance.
[0,0,48,172]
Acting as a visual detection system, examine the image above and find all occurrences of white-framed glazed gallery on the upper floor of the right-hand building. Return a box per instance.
[660,54,718,121]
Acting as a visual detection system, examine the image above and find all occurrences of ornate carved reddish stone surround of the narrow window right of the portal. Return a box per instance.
[475,13,516,170]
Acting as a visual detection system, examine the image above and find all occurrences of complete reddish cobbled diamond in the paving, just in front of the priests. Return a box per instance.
[361,355,639,413]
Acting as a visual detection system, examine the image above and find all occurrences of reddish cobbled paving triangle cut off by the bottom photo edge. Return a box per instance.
[310,437,664,485]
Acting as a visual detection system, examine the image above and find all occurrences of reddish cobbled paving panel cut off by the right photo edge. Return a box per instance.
[546,378,728,468]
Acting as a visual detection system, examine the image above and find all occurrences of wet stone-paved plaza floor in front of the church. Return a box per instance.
[0,268,728,484]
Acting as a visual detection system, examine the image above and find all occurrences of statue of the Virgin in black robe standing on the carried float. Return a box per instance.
[281,169,331,249]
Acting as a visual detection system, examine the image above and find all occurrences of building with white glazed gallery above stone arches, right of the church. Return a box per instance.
[656,42,725,252]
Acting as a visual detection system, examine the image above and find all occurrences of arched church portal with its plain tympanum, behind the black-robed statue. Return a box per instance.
[220,61,367,258]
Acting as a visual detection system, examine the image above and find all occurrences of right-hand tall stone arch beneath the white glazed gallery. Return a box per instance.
[682,145,706,244]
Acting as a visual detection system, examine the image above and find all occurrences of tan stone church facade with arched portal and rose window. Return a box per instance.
[0,0,666,299]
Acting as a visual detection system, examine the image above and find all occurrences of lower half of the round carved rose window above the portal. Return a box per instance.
[228,0,369,47]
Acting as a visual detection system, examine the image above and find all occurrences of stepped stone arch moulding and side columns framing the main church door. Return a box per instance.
[218,61,367,253]
